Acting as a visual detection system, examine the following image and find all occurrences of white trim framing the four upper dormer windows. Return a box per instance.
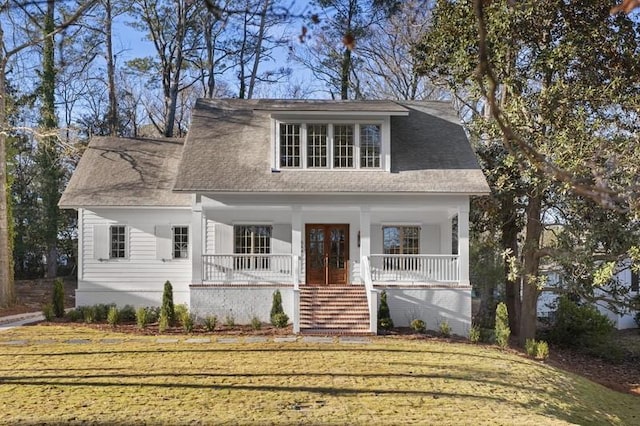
[271,117,391,172]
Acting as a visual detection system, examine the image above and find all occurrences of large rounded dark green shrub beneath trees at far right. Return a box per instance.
[547,296,614,348]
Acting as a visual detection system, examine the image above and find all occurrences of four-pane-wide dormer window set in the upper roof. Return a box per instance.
[275,121,384,169]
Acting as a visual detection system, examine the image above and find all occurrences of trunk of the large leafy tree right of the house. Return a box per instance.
[518,186,543,346]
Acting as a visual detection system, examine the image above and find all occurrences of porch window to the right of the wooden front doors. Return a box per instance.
[382,226,420,270]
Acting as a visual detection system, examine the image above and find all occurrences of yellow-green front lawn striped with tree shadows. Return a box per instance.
[0,326,640,425]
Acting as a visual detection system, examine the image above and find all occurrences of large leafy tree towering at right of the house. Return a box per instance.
[417,0,640,343]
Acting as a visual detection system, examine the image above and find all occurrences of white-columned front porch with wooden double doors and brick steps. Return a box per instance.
[191,195,471,334]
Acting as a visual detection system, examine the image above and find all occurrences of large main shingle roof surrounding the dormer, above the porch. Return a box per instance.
[174,99,489,194]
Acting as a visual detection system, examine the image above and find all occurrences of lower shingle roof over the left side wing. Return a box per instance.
[59,137,191,208]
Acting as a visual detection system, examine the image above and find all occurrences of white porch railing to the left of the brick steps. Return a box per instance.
[202,254,298,284]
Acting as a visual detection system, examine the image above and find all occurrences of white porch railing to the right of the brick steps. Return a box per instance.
[369,254,460,283]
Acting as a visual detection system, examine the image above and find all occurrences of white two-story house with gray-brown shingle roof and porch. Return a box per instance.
[60,99,489,335]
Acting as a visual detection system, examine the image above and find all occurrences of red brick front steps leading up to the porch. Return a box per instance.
[300,285,371,334]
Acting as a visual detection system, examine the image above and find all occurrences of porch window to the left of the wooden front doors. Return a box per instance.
[234,225,272,269]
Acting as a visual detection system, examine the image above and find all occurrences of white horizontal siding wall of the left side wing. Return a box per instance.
[76,209,191,305]
